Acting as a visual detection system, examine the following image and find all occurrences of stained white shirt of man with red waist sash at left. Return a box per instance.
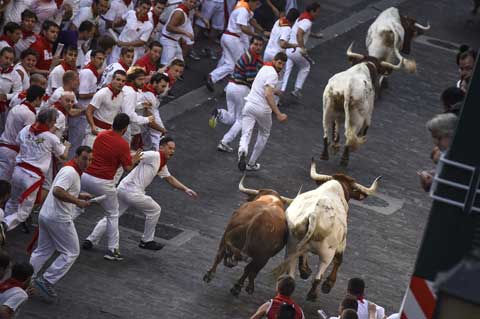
[16,125,65,175]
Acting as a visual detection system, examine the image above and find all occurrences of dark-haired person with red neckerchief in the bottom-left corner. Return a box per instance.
[0,263,33,318]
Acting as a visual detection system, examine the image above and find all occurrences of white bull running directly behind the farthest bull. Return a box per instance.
[320,43,402,166]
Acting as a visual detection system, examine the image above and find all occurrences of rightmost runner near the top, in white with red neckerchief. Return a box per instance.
[281,2,322,97]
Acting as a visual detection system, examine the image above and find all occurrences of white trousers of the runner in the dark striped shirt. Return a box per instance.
[219,82,250,144]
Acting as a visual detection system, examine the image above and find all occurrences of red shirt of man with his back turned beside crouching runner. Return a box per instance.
[85,130,132,180]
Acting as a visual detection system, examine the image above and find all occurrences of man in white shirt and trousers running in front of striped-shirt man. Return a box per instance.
[238,52,287,171]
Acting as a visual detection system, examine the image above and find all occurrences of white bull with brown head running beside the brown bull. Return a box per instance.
[274,159,381,300]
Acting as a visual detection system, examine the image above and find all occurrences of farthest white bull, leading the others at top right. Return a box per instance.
[365,7,430,73]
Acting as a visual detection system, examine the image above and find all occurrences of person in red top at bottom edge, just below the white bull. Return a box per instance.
[250,275,305,319]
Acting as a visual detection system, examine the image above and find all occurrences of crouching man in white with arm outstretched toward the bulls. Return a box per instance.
[84,136,198,250]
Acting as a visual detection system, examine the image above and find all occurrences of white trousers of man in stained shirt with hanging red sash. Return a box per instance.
[5,166,41,230]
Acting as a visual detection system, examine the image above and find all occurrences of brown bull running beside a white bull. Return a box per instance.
[203,176,292,296]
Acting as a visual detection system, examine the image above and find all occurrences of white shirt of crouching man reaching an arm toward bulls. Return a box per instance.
[118,151,170,194]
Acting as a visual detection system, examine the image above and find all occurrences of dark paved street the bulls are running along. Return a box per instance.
[10,0,480,319]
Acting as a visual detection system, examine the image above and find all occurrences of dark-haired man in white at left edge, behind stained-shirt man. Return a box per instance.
[0,86,45,180]
